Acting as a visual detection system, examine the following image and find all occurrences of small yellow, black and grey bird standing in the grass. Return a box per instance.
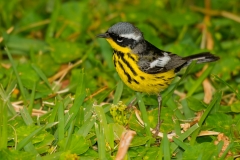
[97,22,219,132]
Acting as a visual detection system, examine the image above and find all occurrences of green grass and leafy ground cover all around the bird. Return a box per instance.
[0,0,240,160]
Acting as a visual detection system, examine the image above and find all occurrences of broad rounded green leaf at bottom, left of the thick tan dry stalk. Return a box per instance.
[58,134,89,155]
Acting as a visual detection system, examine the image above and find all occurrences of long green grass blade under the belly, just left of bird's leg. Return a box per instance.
[136,92,152,147]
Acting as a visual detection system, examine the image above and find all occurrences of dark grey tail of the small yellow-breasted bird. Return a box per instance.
[175,52,219,72]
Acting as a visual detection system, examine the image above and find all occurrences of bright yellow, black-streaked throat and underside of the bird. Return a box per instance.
[107,39,175,94]
